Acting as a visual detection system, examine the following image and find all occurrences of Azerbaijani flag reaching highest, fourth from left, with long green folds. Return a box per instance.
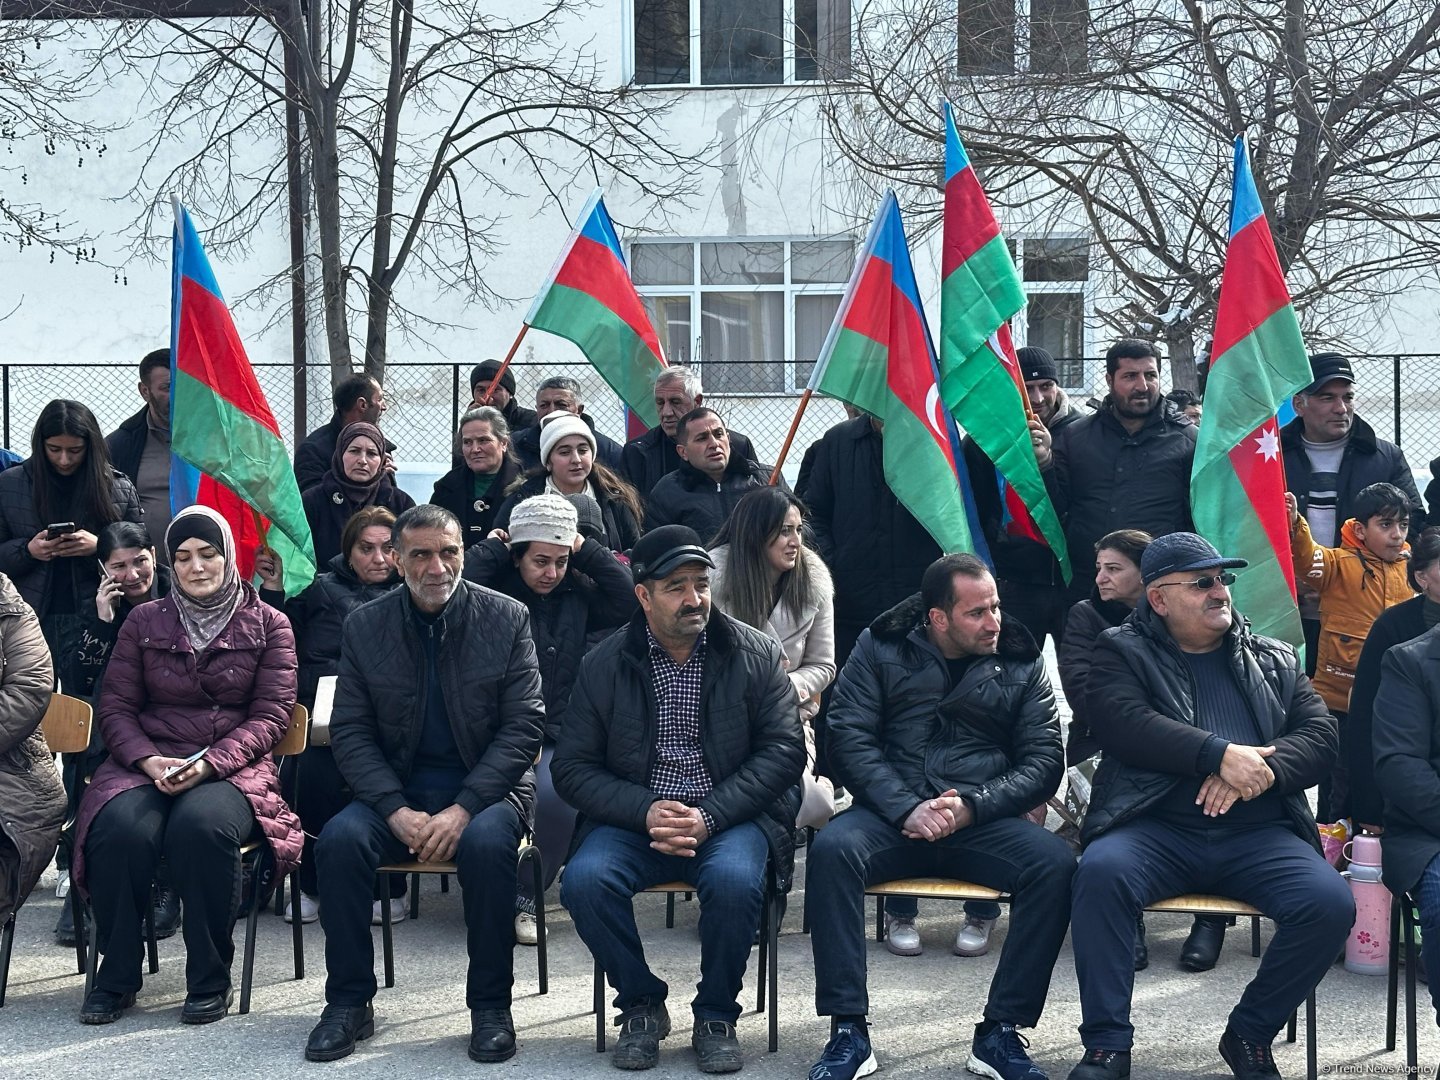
[940,102,1070,582]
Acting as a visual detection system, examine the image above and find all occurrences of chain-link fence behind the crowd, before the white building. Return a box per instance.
[8,354,1440,494]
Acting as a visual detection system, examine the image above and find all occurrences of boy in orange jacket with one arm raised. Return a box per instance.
[1284,484,1416,821]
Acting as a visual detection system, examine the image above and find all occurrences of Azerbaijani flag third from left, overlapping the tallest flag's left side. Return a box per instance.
[809,192,989,562]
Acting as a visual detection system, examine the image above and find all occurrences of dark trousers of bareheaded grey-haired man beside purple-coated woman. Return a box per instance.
[315,796,521,1009]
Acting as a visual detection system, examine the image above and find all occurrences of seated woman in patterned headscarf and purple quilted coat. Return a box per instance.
[73,507,301,1024]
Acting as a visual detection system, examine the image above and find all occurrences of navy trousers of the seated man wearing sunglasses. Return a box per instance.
[1070,818,1355,1050]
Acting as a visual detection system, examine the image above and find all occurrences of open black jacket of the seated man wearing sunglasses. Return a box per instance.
[1080,599,1338,851]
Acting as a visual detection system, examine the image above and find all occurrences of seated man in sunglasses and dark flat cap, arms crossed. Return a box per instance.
[1070,533,1355,1080]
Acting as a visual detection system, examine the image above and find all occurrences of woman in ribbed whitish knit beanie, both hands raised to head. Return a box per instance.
[464,492,635,945]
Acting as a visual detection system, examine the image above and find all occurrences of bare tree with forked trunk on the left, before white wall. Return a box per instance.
[74,0,711,377]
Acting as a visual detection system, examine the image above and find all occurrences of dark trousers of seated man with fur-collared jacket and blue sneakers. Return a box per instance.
[805,806,1076,1027]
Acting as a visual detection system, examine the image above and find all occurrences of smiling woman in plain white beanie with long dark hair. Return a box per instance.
[495,412,642,552]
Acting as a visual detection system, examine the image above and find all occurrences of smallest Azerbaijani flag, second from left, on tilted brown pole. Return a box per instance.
[526,187,665,428]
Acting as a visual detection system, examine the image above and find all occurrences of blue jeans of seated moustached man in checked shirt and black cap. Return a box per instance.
[555,821,770,1024]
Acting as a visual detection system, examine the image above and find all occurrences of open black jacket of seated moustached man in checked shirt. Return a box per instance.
[550,611,805,890]
